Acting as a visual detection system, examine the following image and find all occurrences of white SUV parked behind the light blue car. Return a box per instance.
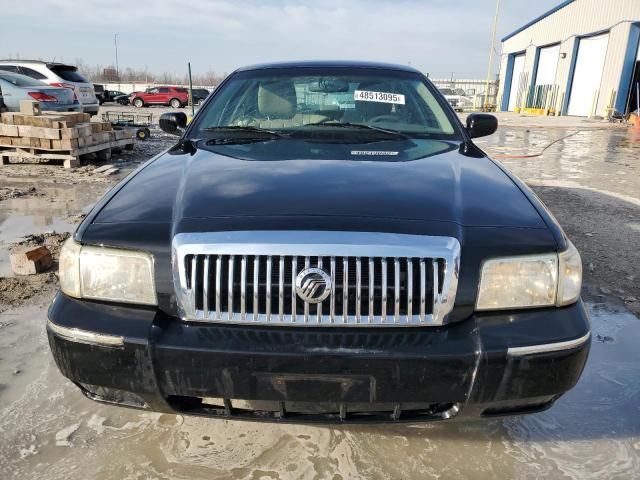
[0,60,100,115]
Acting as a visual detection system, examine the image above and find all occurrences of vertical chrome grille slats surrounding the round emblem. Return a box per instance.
[179,232,459,326]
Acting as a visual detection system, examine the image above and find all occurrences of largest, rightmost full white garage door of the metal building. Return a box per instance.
[567,34,609,117]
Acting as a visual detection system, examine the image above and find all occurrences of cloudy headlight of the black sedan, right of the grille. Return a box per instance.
[476,242,582,310]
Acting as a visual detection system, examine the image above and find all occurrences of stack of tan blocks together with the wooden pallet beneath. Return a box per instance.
[0,102,133,166]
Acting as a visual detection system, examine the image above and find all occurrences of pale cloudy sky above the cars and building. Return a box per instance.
[0,0,560,78]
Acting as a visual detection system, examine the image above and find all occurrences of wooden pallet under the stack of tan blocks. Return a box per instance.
[0,138,135,168]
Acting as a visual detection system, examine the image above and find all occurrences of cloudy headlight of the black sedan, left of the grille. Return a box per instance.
[59,238,157,305]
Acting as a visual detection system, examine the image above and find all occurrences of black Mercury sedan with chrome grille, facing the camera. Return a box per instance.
[48,62,591,423]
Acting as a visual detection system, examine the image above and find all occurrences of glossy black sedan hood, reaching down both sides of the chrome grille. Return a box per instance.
[84,140,557,321]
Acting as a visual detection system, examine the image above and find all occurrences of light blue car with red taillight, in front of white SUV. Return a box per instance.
[0,71,82,112]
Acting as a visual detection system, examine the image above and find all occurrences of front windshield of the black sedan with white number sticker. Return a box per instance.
[190,67,458,139]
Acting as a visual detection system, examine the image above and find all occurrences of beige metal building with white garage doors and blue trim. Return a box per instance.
[498,0,640,117]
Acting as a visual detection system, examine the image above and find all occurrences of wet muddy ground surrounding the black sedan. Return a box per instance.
[0,107,640,480]
